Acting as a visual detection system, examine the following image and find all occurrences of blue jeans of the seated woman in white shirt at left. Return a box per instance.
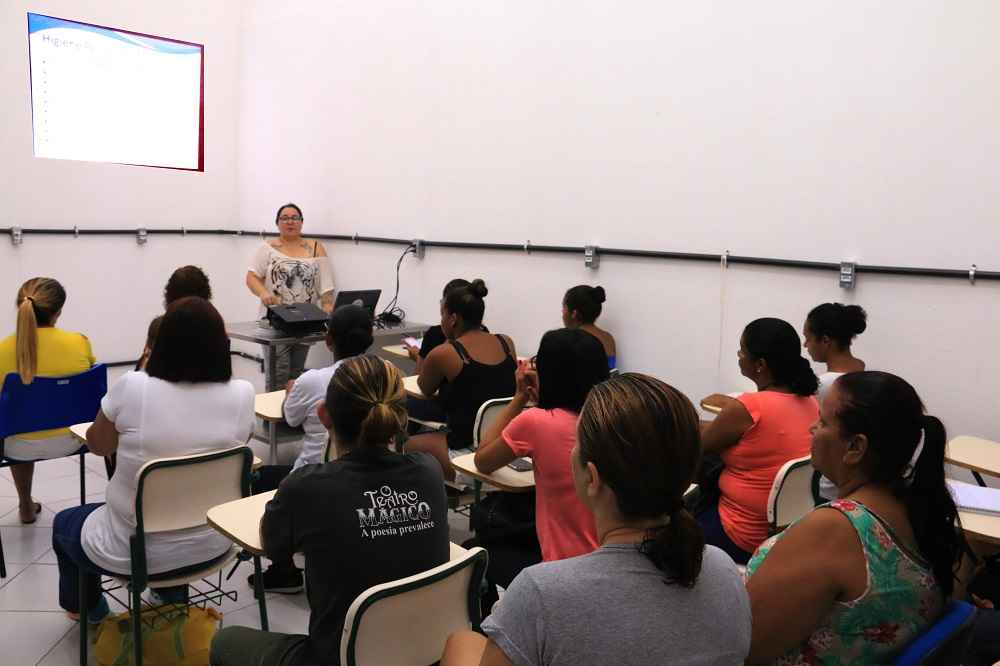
[52,503,111,613]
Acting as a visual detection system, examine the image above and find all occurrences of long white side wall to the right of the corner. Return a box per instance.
[238,0,1000,452]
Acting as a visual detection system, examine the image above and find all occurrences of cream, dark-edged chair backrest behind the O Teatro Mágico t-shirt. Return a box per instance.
[340,548,487,666]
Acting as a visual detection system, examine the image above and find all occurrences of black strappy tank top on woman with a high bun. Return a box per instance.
[444,335,517,449]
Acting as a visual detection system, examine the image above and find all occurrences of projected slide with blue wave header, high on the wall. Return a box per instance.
[28,14,204,171]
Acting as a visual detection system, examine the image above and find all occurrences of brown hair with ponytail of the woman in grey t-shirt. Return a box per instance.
[577,373,705,587]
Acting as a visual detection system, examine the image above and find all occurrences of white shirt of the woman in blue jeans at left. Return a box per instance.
[80,372,254,573]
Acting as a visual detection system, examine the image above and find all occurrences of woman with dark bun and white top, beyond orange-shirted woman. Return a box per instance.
[802,303,868,500]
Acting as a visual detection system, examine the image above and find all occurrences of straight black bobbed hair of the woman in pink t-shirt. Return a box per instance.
[535,328,608,412]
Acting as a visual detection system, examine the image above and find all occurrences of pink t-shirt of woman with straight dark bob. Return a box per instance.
[501,408,597,562]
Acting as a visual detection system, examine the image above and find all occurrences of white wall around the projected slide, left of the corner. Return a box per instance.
[0,0,266,382]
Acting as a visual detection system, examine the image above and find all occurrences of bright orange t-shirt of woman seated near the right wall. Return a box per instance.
[719,391,819,553]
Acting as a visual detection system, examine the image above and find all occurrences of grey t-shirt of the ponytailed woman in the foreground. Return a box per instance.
[483,544,750,666]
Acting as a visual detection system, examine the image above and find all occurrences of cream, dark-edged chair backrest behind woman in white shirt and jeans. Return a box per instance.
[135,445,253,534]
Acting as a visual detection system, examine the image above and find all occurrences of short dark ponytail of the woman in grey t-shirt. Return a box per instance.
[639,506,705,587]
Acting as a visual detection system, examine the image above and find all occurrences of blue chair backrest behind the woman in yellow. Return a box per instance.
[0,363,108,438]
